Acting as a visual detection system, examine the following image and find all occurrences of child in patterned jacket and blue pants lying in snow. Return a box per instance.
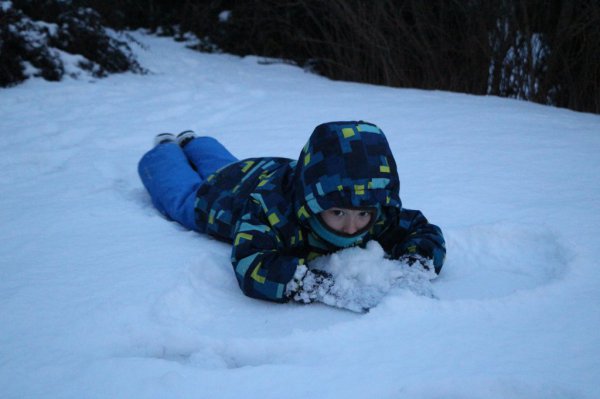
[138,121,446,312]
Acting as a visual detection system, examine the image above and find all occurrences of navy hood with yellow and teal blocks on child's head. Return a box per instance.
[294,121,402,233]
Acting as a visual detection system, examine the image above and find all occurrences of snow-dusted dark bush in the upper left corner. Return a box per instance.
[0,0,144,86]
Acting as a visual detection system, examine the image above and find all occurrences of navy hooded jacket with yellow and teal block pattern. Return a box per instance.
[196,121,446,302]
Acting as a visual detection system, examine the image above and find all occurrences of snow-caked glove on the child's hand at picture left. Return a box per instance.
[286,265,335,303]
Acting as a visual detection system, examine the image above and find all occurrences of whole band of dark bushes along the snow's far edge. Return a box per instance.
[0,0,600,113]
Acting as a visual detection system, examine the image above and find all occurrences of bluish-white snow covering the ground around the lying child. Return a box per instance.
[0,32,600,399]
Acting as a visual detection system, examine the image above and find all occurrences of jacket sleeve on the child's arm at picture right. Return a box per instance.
[377,209,446,274]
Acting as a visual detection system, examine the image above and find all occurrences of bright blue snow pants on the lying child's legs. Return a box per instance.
[138,137,238,230]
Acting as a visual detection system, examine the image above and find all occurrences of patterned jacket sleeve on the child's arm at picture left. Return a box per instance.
[231,200,305,302]
